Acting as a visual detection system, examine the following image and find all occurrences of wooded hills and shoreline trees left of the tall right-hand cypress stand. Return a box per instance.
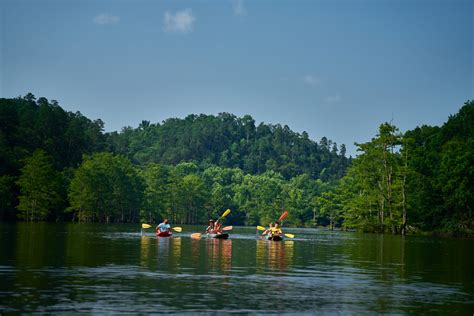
[0,94,351,225]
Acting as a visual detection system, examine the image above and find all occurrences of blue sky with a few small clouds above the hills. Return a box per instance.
[0,0,474,156]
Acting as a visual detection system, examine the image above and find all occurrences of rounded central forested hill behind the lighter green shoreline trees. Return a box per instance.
[107,113,350,181]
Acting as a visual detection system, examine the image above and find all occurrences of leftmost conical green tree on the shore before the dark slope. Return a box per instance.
[16,149,63,221]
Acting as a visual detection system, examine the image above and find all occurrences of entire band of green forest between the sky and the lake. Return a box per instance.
[0,94,474,234]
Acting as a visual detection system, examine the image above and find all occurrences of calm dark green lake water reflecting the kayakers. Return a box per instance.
[0,223,474,315]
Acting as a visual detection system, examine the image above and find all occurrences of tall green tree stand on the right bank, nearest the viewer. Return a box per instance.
[318,101,474,234]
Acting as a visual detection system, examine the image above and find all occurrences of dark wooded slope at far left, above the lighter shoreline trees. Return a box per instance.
[0,93,107,176]
